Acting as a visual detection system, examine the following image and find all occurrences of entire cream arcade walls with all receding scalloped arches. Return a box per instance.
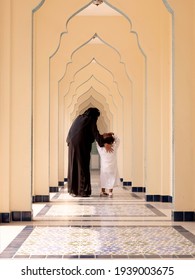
[0,0,195,218]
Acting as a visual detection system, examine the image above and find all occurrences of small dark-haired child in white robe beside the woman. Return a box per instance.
[96,133,120,198]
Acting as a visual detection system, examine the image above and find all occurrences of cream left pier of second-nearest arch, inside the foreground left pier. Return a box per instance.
[33,0,92,192]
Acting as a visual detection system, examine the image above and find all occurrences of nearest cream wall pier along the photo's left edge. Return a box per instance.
[0,0,40,212]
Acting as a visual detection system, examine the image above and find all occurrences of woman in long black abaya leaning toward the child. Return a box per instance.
[66,108,112,196]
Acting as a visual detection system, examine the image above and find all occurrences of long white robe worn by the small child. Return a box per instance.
[96,136,120,189]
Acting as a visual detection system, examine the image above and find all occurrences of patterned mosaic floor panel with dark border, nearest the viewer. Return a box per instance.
[0,226,195,258]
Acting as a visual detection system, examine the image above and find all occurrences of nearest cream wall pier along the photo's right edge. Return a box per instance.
[169,0,195,211]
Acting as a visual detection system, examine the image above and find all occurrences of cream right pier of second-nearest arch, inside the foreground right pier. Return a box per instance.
[121,1,172,195]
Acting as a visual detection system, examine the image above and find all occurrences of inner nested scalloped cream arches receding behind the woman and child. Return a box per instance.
[32,0,172,201]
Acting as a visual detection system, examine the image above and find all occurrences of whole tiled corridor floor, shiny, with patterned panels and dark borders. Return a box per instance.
[0,172,195,259]
